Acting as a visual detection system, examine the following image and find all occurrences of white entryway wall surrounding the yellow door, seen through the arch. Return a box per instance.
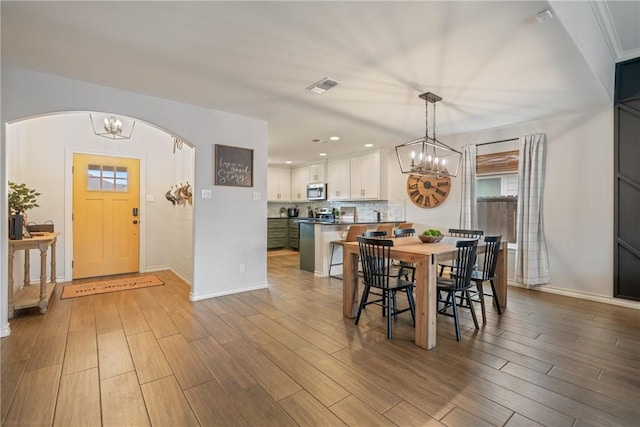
[7,112,194,289]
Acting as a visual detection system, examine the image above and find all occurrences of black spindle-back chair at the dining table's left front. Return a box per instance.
[355,237,416,339]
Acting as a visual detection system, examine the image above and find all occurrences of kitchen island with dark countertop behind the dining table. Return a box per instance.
[298,218,405,277]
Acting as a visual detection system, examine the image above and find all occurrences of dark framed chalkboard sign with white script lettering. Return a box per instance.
[213,144,253,187]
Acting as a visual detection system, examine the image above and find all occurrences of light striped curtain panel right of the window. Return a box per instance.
[515,133,551,285]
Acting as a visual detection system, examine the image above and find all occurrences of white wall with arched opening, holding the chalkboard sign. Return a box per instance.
[0,64,267,335]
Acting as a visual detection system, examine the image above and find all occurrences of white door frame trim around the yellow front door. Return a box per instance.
[64,148,147,282]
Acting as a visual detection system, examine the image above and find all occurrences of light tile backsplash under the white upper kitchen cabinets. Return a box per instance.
[267,200,406,221]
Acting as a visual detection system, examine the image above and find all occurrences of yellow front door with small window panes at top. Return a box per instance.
[73,154,140,279]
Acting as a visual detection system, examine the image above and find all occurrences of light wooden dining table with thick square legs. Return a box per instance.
[342,236,507,350]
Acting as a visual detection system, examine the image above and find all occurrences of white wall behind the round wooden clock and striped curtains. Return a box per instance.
[389,106,640,307]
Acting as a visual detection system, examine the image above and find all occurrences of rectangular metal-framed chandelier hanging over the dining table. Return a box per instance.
[396,92,462,177]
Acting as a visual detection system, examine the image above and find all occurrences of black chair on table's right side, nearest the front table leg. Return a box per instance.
[437,240,479,341]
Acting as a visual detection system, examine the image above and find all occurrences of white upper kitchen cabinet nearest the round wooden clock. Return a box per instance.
[351,151,387,200]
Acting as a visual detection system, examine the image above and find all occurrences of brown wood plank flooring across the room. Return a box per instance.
[0,253,640,427]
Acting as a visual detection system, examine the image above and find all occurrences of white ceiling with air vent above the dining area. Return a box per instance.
[1,1,640,164]
